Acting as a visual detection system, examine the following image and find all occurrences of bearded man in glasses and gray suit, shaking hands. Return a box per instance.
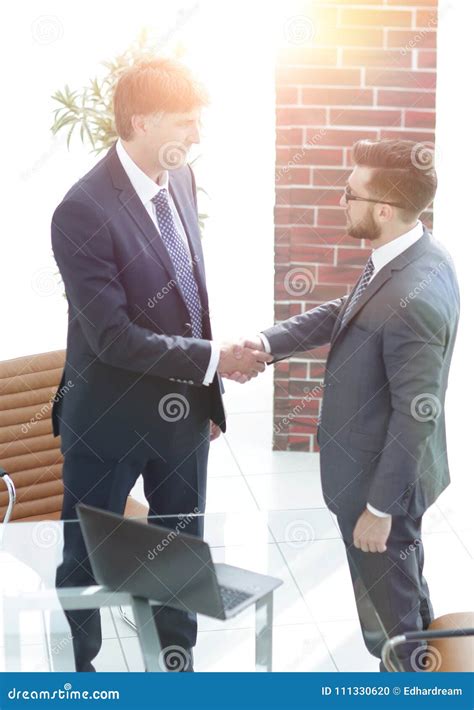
[243,140,459,671]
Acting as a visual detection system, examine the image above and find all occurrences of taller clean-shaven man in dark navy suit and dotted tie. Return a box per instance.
[52,59,270,671]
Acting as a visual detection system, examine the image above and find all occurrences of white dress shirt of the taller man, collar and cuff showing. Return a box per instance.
[116,140,220,385]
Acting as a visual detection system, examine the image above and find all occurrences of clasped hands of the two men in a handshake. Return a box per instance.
[217,336,273,384]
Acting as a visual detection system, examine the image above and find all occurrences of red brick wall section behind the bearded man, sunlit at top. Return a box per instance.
[274,0,437,451]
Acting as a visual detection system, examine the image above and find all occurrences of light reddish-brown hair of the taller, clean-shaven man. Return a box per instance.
[114,57,208,141]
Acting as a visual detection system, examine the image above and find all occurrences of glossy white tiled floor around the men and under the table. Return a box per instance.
[0,374,473,671]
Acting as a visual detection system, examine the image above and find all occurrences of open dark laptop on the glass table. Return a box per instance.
[76,503,283,619]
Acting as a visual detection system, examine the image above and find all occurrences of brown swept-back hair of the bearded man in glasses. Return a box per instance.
[352,139,437,222]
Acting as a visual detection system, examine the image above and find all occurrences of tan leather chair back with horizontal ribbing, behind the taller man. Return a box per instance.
[0,350,65,522]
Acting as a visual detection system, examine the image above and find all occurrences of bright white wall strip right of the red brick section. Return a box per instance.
[435,0,474,486]
